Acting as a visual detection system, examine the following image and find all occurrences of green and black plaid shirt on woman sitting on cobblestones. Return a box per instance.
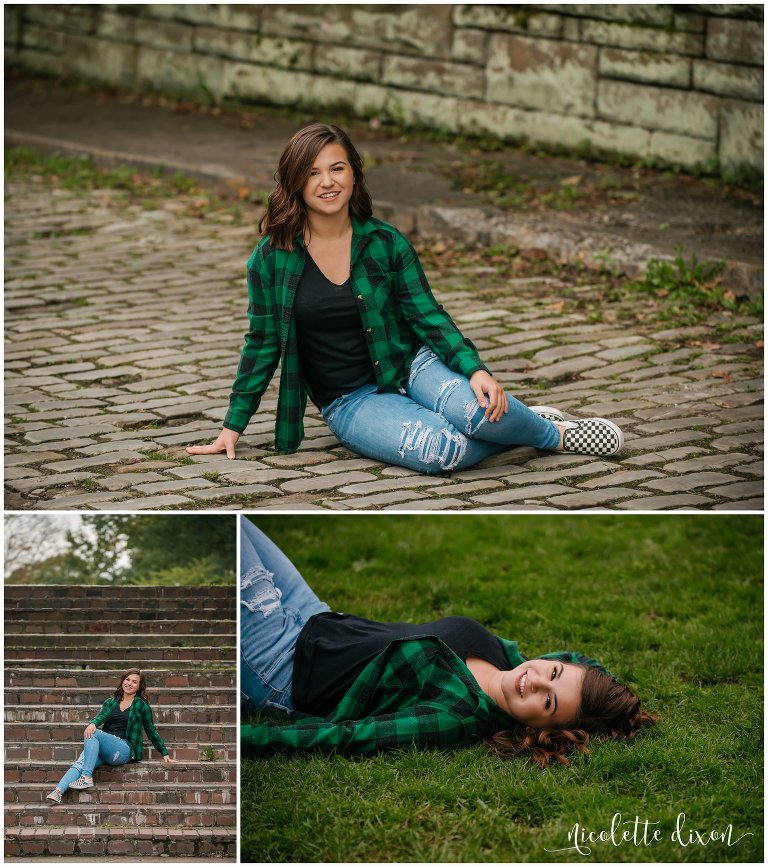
[224,217,487,452]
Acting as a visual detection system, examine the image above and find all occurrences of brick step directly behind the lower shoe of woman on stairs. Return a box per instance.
[5,784,236,809]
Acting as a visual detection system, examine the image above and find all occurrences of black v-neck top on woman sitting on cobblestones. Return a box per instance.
[293,253,376,409]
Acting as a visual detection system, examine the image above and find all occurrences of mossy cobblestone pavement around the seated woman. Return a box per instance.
[5,179,763,511]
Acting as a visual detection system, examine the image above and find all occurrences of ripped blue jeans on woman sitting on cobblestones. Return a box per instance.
[322,346,560,474]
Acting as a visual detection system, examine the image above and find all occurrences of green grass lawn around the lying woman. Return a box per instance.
[241,514,763,862]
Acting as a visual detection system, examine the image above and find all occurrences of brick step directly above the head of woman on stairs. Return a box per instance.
[5,639,235,660]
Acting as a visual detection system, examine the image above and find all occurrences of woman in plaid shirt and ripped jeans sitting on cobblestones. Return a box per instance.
[187,124,623,473]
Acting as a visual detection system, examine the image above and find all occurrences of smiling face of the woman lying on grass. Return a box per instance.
[501,659,584,728]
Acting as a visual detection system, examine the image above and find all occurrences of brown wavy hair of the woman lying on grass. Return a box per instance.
[486,665,658,768]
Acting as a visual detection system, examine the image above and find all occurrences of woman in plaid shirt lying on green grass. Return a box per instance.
[240,518,654,767]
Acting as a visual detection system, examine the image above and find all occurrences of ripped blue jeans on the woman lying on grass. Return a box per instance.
[240,516,330,714]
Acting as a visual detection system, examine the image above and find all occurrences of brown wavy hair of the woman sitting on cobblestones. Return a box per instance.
[259,123,373,250]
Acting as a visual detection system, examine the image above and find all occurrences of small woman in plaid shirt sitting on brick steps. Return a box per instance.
[46,668,172,804]
